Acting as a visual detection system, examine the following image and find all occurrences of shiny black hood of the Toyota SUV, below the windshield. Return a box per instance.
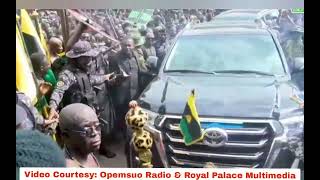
[138,74,299,118]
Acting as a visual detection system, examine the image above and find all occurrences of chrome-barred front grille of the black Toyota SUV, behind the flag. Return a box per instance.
[161,116,274,168]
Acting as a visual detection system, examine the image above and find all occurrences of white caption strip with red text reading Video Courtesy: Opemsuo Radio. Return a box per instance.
[20,168,300,180]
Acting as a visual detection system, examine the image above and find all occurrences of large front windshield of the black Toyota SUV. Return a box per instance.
[164,34,285,76]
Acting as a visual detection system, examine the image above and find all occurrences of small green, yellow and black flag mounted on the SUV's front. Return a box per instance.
[180,90,203,146]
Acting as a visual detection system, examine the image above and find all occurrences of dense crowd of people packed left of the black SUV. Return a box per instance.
[16,9,304,167]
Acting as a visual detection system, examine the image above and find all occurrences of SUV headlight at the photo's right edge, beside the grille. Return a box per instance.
[280,116,304,161]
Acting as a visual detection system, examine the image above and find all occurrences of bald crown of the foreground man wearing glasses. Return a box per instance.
[59,103,98,130]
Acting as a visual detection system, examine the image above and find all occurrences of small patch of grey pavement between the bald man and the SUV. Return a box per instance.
[96,140,127,168]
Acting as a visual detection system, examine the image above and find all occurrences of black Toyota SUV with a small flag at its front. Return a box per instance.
[127,22,304,168]
